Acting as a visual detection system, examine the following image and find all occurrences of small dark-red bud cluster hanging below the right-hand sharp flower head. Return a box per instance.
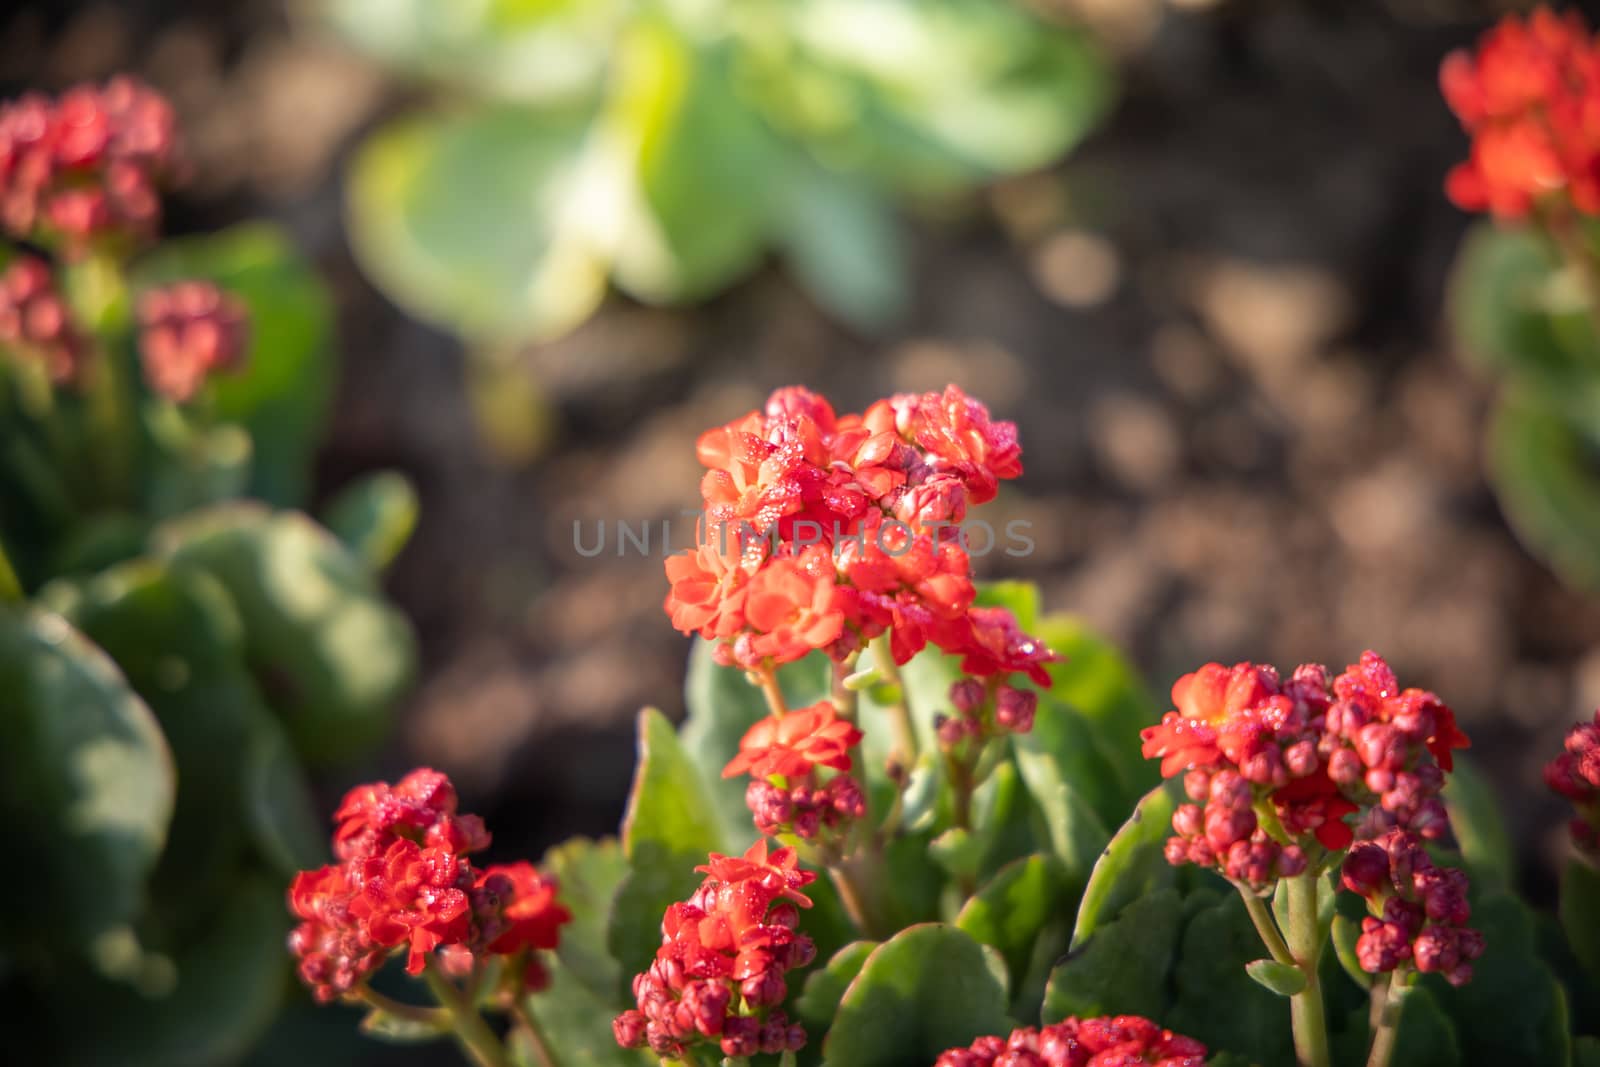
[1342,830,1483,985]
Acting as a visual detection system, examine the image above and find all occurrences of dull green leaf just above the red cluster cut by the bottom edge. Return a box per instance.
[1043,888,1184,1022]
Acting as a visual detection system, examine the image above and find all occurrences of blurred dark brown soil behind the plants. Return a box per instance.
[0,0,1600,953]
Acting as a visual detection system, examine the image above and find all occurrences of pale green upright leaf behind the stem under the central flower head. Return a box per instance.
[682,637,832,848]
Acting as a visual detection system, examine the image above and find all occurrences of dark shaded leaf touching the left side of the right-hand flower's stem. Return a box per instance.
[1171,893,1294,1064]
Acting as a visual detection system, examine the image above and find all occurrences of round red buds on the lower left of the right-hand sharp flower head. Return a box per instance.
[1165,769,1307,889]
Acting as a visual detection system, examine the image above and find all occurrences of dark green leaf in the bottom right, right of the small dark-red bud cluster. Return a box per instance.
[1426,893,1571,1064]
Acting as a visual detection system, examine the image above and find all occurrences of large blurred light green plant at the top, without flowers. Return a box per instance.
[323,0,1112,341]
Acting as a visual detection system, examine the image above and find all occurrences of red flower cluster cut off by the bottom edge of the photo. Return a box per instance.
[934,1016,1206,1067]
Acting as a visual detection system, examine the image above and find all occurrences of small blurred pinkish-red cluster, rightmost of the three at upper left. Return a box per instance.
[139,282,250,403]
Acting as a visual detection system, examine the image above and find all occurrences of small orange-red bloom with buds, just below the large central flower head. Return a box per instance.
[722,701,867,840]
